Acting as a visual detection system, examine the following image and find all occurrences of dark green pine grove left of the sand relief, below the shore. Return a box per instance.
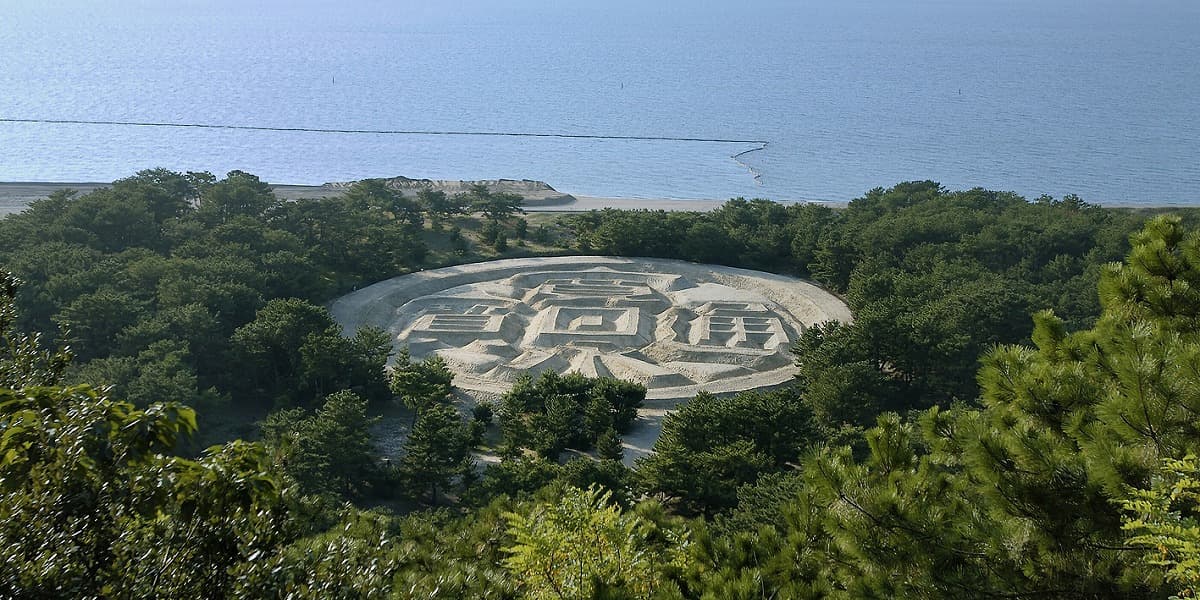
[0,169,425,439]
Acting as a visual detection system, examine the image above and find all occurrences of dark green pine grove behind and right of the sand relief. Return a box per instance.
[568,181,1139,417]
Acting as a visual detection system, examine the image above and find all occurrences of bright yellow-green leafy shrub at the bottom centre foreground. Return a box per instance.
[504,487,689,600]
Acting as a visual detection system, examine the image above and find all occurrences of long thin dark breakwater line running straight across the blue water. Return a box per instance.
[0,118,768,146]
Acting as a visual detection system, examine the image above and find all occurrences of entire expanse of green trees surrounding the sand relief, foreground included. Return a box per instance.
[0,170,1200,599]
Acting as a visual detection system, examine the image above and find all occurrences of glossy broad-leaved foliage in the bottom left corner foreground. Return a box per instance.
[0,386,297,598]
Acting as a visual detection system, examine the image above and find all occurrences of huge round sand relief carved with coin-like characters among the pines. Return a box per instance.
[331,257,851,400]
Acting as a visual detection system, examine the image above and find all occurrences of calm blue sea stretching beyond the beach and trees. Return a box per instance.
[0,0,1200,203]
